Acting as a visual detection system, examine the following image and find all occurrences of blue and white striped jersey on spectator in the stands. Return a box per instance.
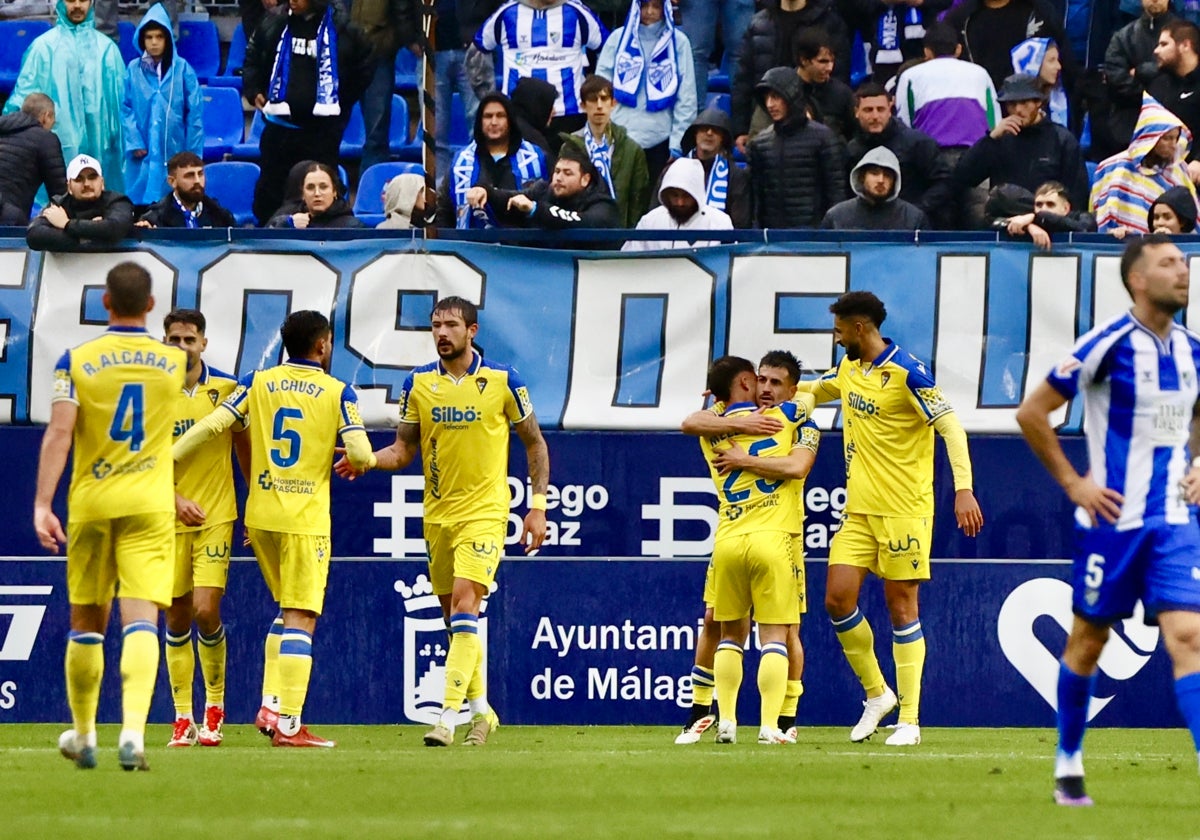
[475,0,605,116]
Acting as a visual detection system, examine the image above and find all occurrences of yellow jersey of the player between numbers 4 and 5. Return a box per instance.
[174,360,238,532]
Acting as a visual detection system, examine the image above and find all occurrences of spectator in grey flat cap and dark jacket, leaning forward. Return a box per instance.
[950,74,1088,224]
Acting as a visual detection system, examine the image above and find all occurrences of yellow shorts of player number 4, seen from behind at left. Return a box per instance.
[67,511,175,607]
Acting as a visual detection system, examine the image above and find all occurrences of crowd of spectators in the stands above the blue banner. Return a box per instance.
[7,0,1200,250]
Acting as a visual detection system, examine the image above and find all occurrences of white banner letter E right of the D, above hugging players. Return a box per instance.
[728,254,850,428]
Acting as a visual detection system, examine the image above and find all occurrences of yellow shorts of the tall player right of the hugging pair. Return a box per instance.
[829,514,934,581]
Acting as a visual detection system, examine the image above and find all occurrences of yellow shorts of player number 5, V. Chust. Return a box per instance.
[246,528,330,616]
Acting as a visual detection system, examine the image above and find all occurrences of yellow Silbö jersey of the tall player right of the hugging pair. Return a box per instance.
[812,341,954,516]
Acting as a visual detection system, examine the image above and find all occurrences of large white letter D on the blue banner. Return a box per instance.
[563,257,715,430]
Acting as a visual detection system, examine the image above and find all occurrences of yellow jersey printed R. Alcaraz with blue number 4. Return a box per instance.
[52,326,187,522]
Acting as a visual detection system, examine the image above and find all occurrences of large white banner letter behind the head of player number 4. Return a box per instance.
[29,251,175,422]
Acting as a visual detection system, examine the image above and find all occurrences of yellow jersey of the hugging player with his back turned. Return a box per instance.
[700,402,820,540]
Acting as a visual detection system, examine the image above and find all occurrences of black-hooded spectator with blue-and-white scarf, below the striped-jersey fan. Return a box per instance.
[438,92,547,229]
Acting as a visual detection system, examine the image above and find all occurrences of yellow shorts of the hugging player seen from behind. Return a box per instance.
[713,530,799,624]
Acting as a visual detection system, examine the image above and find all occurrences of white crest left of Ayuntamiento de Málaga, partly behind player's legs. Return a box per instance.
[392,575,496,724]
